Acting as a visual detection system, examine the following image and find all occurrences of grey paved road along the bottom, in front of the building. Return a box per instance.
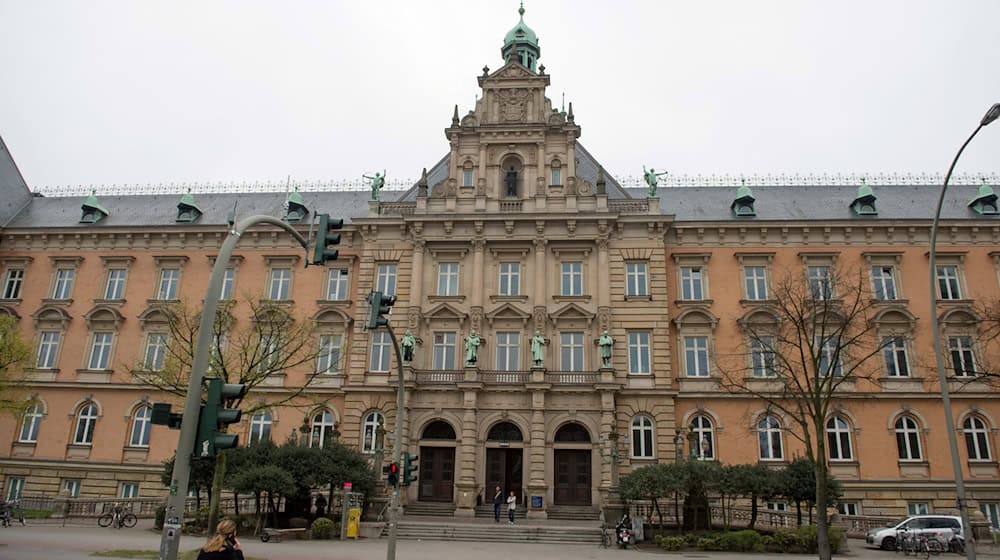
[0,526,998,560]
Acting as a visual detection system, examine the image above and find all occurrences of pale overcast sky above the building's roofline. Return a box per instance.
[0,0,1000,188]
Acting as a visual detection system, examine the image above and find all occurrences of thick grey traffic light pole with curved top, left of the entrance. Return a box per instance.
[160,215,310,560]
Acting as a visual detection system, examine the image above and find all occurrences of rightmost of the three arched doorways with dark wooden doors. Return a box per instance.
[552,422,591,506]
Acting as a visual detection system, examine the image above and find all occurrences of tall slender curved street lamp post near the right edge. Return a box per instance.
[929,103,1000,560]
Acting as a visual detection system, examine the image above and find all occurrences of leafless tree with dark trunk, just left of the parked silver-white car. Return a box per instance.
[716,266,893,560]
